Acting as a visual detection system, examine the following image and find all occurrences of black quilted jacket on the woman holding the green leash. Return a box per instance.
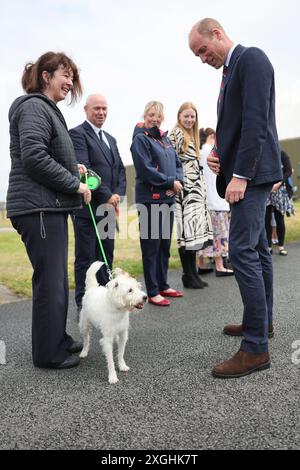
[6,93,81,217]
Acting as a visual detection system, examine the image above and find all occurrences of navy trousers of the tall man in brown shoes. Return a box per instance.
[229,184,273,353]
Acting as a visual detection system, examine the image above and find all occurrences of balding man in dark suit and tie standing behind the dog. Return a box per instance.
[70,94,126,310]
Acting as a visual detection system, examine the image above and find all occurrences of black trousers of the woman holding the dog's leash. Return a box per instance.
[11,212,73,367]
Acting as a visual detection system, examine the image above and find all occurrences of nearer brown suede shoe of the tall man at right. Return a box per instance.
[212,350,271,379]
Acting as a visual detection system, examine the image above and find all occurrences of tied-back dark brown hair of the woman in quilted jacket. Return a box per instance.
[22,51,82,102]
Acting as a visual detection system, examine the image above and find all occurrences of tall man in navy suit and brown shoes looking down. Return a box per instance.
[189,18,282,378]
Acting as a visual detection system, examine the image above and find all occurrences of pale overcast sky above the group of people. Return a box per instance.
[0,0,300,201]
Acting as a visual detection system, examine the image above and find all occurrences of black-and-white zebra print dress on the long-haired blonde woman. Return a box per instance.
[169,127,213,251]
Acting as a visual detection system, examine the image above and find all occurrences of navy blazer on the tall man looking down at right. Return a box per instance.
[216,45,282,197]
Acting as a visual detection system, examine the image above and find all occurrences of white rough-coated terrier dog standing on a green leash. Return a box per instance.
[79,261,147,384]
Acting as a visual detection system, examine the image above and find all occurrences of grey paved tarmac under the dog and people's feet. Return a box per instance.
[0,243,300,450]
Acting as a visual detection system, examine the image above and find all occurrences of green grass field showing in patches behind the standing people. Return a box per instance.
[0,200,300,297]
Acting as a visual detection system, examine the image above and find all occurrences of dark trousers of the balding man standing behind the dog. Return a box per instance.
[73,216,115,306]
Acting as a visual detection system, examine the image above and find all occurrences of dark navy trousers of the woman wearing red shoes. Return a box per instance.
[137,204,174,297]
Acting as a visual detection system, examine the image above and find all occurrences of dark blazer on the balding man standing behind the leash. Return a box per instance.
[69,121,126,217]
